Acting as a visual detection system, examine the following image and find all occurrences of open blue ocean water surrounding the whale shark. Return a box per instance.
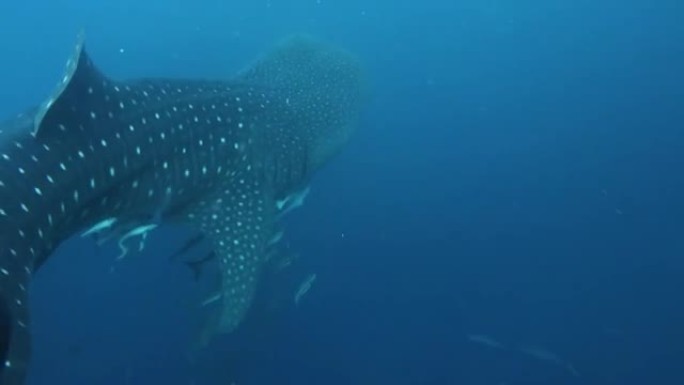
[0,0,684,385]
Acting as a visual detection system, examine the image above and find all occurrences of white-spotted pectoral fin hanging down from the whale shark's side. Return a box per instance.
[187,177,275,342]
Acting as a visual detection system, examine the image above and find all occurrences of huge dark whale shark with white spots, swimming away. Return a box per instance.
[0,33,363,385]
